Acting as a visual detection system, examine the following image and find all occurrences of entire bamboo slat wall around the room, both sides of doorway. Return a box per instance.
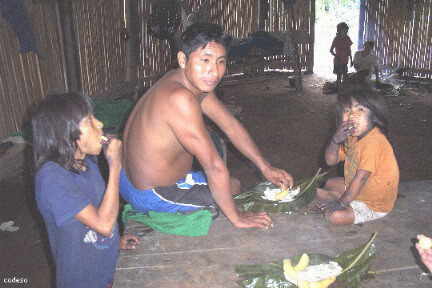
[0,0,432,139]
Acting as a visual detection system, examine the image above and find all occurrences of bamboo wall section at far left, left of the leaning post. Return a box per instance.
[0,1,65,139]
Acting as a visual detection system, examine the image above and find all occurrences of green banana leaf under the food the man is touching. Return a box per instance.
[234,169,327,213]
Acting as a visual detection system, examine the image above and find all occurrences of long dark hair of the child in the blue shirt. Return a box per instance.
[32,92,92,172]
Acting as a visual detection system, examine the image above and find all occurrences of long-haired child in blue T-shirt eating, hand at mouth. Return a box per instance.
[32,93,139,288]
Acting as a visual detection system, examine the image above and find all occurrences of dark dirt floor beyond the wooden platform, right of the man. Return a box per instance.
[221,74,432,187]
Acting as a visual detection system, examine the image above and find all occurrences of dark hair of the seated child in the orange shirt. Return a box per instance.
[337,83,388,134]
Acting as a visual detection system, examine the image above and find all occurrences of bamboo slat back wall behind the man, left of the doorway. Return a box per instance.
[138,0,314,84]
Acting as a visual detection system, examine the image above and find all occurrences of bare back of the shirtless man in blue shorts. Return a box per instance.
[123,70,193,189]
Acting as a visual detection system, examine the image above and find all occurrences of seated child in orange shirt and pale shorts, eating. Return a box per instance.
[317,87,399,225]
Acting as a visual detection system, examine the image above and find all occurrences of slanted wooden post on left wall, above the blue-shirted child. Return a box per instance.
[56,0,82,92]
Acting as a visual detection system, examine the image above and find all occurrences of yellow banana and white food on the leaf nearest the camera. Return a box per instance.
[283,253,342,288]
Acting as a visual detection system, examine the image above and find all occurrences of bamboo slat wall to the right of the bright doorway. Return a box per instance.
[363,0,432,79]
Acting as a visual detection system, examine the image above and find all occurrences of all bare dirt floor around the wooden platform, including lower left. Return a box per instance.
[0,73,432,288]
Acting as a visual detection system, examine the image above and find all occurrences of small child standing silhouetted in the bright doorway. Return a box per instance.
[330,22,353,88]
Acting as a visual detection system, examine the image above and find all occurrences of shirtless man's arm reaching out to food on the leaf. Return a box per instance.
[201,93,293,187]
